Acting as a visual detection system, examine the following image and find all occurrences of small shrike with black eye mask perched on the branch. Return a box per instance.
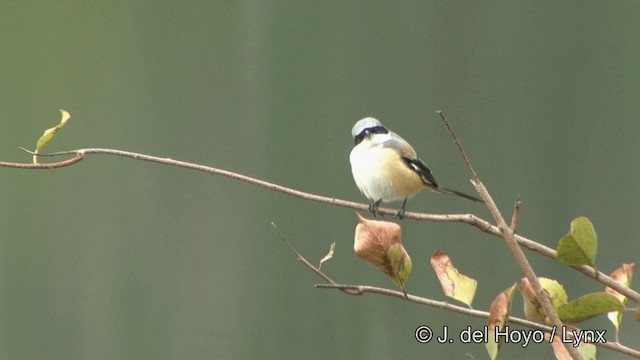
[349,117,482,219]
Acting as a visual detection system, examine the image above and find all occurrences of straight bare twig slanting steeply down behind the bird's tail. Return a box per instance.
[438,111,582,359]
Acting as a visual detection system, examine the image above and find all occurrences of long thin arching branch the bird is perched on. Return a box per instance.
[0,148,640,304]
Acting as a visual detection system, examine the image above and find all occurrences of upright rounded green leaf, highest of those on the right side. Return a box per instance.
[556,216,598,265]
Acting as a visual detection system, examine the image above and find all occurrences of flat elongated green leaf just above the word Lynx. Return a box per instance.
[558,292,624,322]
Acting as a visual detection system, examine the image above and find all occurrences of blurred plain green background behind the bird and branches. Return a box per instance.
[0,0,640,359]
